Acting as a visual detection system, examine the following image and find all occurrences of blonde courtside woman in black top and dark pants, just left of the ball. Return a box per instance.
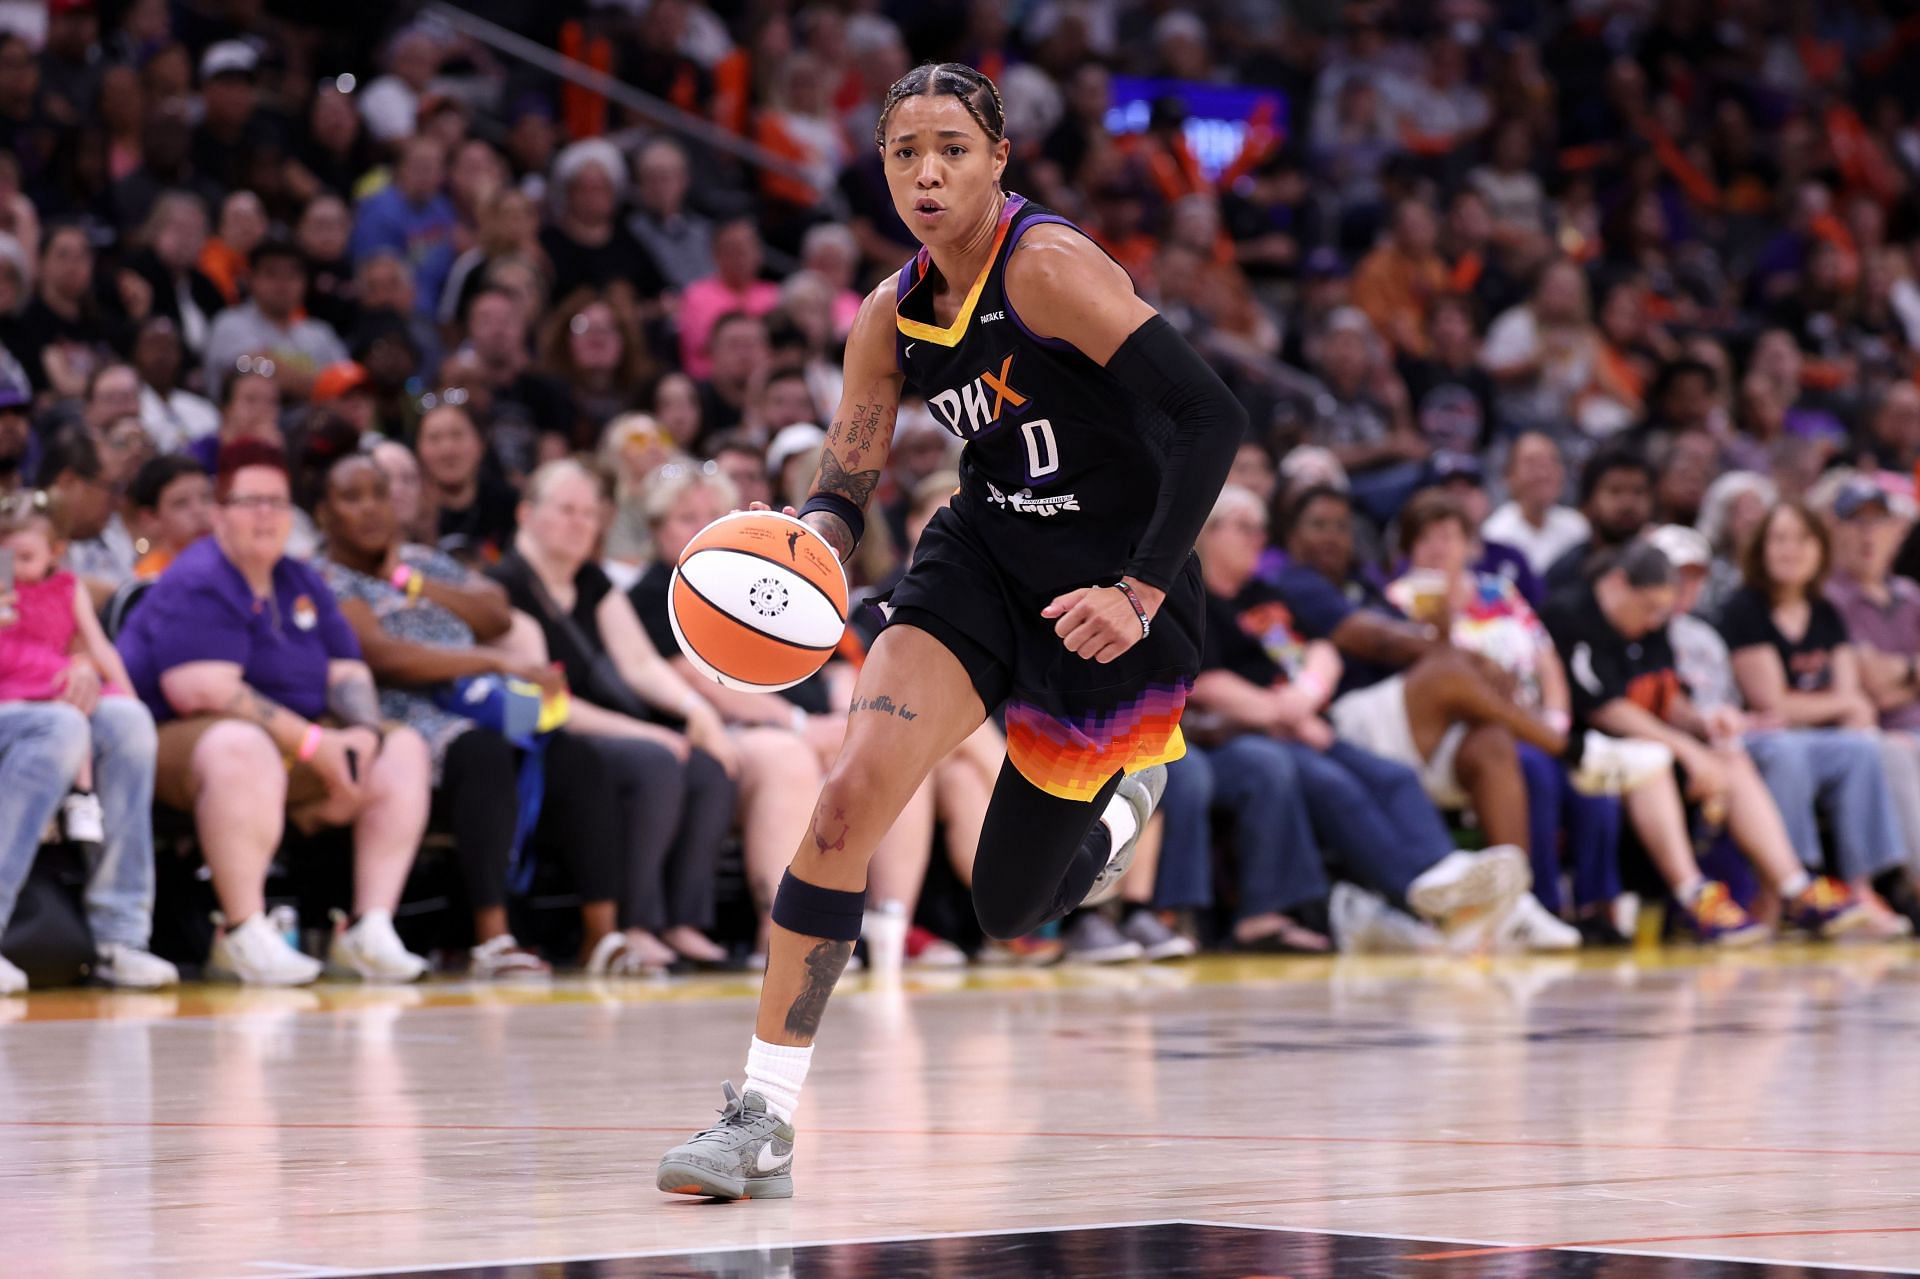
[490,461,737,972]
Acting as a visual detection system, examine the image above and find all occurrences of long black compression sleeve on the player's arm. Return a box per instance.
[1106,315,1246,591]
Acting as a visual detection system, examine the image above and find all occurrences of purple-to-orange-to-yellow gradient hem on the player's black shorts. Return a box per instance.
[1006,680,1192,803]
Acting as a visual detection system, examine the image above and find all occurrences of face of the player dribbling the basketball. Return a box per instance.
[881,96,1010,248]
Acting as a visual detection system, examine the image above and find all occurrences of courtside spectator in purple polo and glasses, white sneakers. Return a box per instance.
[119,442,430,985]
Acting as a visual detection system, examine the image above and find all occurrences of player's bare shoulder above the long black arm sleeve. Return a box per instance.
[1006,223,1154,365]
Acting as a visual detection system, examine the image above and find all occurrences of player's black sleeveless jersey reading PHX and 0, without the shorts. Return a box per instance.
[895,194,1171,593]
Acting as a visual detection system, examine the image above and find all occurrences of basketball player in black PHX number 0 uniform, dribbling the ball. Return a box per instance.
[659,63,1511,1198]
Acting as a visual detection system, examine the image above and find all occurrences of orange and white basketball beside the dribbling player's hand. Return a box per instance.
[666,511,847,693]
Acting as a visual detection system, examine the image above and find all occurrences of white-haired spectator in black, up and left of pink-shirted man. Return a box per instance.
[540,138,664,307]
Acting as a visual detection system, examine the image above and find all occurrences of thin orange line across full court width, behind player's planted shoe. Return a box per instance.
[0,1120,1920,1159]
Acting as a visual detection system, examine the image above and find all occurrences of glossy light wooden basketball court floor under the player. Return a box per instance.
[0,947,1920,1279]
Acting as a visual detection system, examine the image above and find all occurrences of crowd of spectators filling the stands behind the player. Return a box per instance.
[0,0,1920,991]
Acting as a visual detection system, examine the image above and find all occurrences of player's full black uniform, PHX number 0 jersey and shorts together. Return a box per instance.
[891,196,1212,801]
